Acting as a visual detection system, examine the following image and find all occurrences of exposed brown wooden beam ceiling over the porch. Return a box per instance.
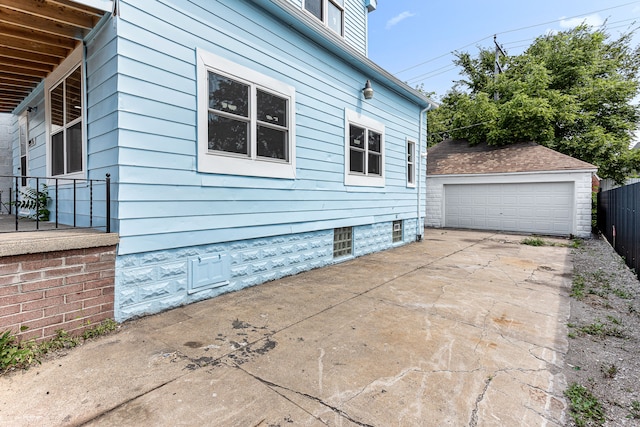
[0,0,105,113]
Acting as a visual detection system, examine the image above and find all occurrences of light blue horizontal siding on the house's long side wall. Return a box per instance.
[113,0,419,254]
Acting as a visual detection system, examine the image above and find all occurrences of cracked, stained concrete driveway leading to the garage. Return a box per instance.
[0,229,572,427]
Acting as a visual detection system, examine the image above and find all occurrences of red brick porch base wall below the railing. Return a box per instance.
[0,246,116,340]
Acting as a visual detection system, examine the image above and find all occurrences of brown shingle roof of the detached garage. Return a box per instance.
[427,140,596,175]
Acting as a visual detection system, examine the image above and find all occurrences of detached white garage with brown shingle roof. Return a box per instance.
[425,141,596,237]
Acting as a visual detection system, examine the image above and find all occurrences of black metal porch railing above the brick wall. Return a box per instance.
[0,174,111,233]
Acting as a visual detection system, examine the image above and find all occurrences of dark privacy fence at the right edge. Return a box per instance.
[598,183,640,279]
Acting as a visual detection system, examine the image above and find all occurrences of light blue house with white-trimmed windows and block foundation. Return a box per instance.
[5,0,433,321]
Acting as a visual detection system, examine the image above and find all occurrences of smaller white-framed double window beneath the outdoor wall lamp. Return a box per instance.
[344,110,385,187]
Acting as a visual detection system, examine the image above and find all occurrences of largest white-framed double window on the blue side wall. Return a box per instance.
[197,49,295,179]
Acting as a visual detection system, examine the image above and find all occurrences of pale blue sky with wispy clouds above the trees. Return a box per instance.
[369,0,640,100]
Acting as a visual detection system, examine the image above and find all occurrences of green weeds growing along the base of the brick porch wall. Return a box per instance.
[0,319,118,374]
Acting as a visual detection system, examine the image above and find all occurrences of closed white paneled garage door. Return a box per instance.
[444,182,574,235]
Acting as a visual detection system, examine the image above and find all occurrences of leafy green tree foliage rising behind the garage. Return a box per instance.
[429,25,640,182]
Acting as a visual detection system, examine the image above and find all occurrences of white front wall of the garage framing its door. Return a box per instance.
[425,171,595,238]
